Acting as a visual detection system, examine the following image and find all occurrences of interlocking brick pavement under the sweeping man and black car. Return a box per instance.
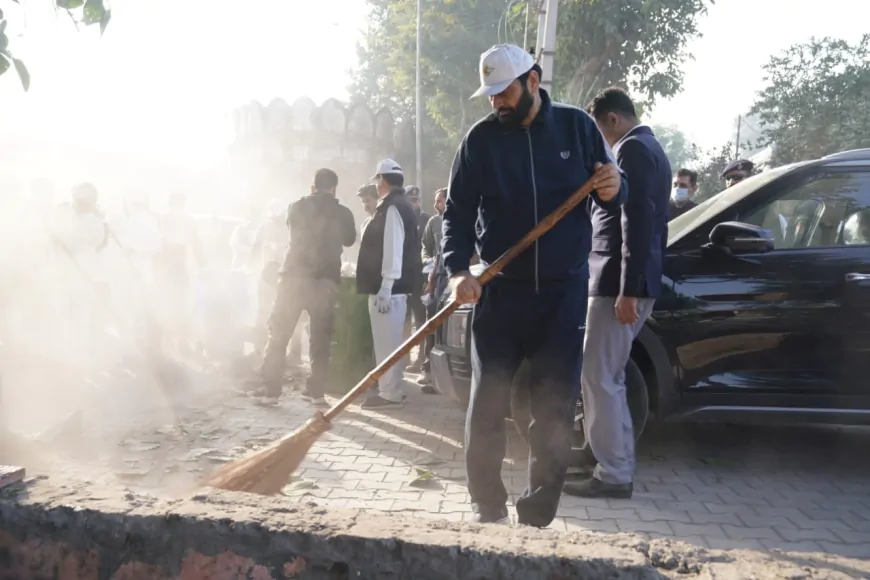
[37,368,870,558]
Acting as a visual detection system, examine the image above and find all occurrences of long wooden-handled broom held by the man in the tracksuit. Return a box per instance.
[202,172,597,495]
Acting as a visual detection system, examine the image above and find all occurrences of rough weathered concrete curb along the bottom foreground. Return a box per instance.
[0,480,859,580]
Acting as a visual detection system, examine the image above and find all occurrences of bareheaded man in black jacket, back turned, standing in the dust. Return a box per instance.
[261,169,356,405]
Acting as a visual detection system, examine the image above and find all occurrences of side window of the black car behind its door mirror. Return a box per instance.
[740,170,870,249]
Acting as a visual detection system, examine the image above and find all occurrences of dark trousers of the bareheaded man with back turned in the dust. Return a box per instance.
[261,276,338,396]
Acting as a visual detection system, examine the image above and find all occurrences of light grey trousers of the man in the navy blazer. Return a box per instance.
[580,296,655,483]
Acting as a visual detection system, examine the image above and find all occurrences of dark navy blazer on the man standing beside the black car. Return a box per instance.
[589,125,673,298]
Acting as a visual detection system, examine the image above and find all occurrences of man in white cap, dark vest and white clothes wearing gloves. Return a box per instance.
[356,159,422,409]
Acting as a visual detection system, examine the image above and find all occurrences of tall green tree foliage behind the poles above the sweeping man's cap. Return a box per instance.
[351,0,708,164]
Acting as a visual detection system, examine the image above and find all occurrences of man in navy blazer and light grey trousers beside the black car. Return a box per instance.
[564,87,672,498]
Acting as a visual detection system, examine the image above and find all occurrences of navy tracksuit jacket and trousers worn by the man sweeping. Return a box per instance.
[442,90,627,526]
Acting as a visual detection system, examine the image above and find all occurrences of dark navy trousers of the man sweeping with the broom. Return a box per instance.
[465,279,587,527]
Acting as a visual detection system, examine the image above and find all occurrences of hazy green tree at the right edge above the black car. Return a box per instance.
[752,34,870,165]
